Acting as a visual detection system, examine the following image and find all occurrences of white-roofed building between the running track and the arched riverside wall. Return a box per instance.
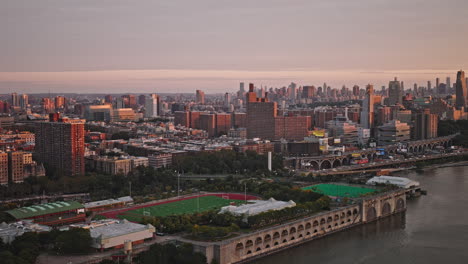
[220,198,296,216]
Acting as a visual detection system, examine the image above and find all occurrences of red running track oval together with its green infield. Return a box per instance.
[101,193,259,222]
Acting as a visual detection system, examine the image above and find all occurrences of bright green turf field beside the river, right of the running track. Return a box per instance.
[302,183,377,198]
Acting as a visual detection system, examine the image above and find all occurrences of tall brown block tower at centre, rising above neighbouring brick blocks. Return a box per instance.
[246,83,278,139]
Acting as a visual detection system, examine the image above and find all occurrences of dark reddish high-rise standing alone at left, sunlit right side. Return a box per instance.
[34,113,85,175]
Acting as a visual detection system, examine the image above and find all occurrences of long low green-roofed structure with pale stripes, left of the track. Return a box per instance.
[6,201,84,219]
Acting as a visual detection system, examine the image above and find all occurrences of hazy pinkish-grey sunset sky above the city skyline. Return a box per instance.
[0,0,468,93]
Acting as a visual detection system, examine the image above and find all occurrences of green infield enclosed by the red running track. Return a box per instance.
[118,196,244,221]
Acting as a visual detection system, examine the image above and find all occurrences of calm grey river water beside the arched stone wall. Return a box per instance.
[253,166,468,264]
